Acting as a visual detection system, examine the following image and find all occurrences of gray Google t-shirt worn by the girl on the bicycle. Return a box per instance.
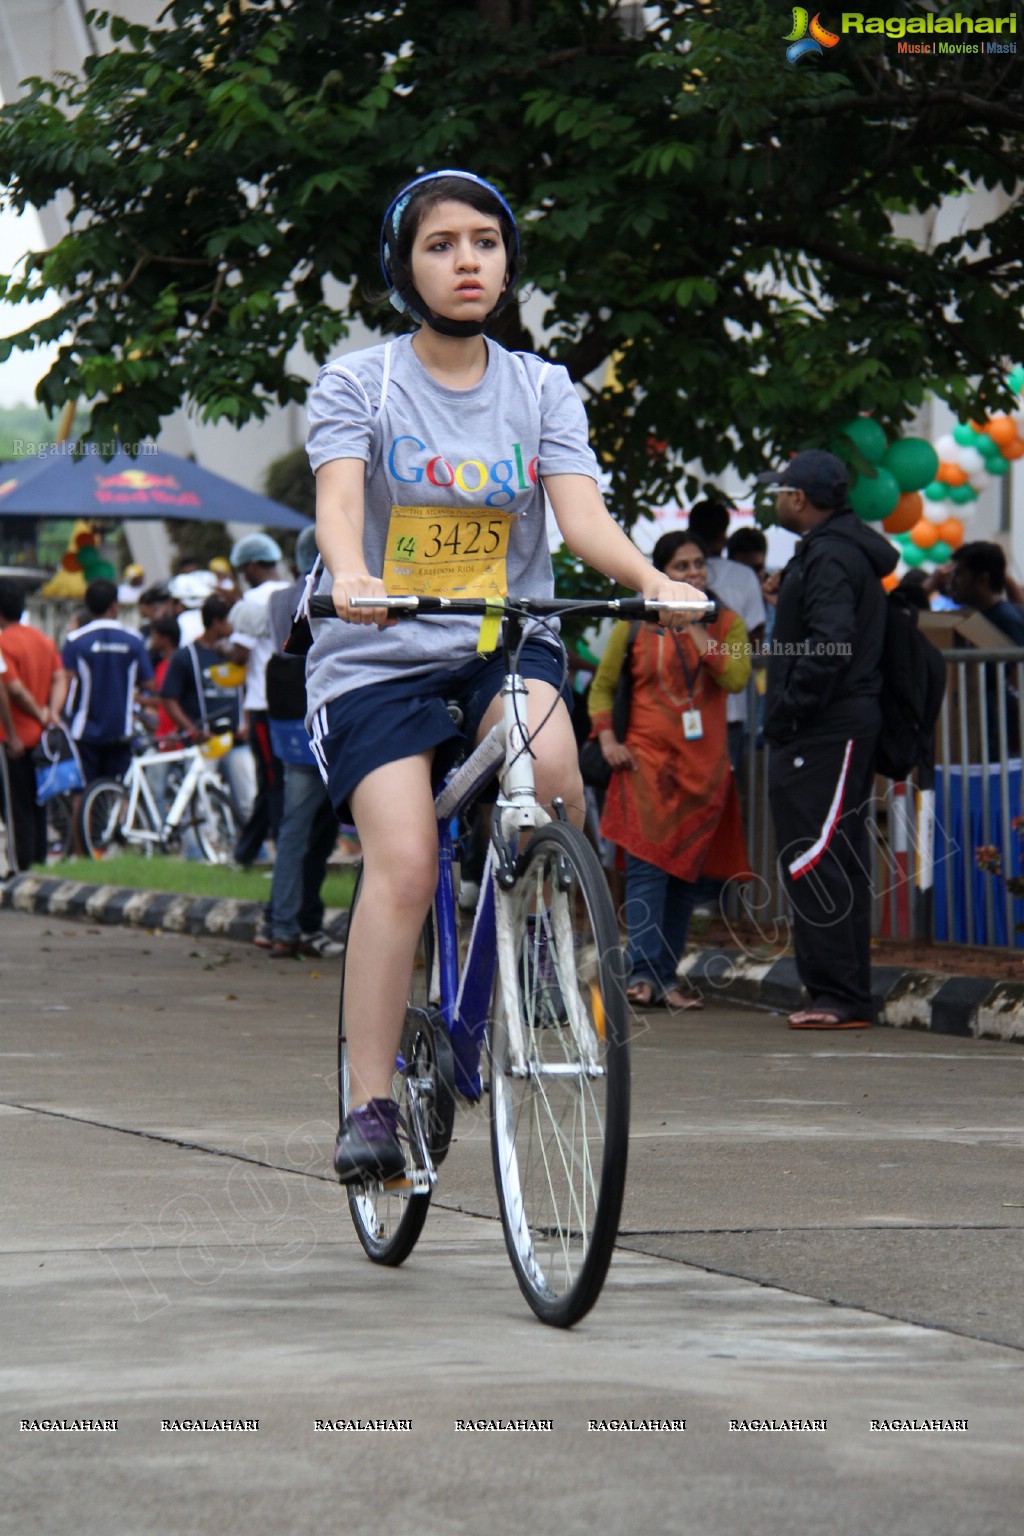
[306,336,597,719]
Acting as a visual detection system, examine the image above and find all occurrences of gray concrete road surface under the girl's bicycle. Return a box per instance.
[0,912,1024,1536]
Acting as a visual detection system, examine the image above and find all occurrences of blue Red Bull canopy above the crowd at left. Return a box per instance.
[0,442,310,528]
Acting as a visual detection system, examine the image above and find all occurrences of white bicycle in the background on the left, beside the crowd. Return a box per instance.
[81,721,238,863]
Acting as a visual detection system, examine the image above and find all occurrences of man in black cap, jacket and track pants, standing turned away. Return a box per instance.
[765,450,898,1029]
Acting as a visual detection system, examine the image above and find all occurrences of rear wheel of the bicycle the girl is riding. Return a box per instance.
[338,871,454,1267]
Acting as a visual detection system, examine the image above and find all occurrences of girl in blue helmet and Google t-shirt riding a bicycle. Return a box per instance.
[307,170,702,1183]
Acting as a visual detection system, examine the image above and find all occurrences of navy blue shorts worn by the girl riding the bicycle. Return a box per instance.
[313,641,571,816]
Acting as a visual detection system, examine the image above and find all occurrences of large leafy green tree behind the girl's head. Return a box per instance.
[0,0,1024,524]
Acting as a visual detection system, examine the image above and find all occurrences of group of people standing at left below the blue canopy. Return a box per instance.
[0,525,344,958]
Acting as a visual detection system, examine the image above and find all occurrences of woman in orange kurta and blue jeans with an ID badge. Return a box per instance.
[590,530,751,1008]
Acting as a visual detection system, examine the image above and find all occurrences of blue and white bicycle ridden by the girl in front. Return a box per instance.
[310,598,714,1327]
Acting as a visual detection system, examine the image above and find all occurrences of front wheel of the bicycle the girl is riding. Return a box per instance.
[490,822,629,1327]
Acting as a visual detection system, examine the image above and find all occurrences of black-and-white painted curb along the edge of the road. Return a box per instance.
[0,874,1024,1040]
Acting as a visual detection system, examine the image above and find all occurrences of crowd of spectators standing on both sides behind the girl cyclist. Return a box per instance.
[0,473,1024,1029]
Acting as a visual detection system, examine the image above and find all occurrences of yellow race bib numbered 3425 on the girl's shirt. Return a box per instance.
[382,507,511,598]
